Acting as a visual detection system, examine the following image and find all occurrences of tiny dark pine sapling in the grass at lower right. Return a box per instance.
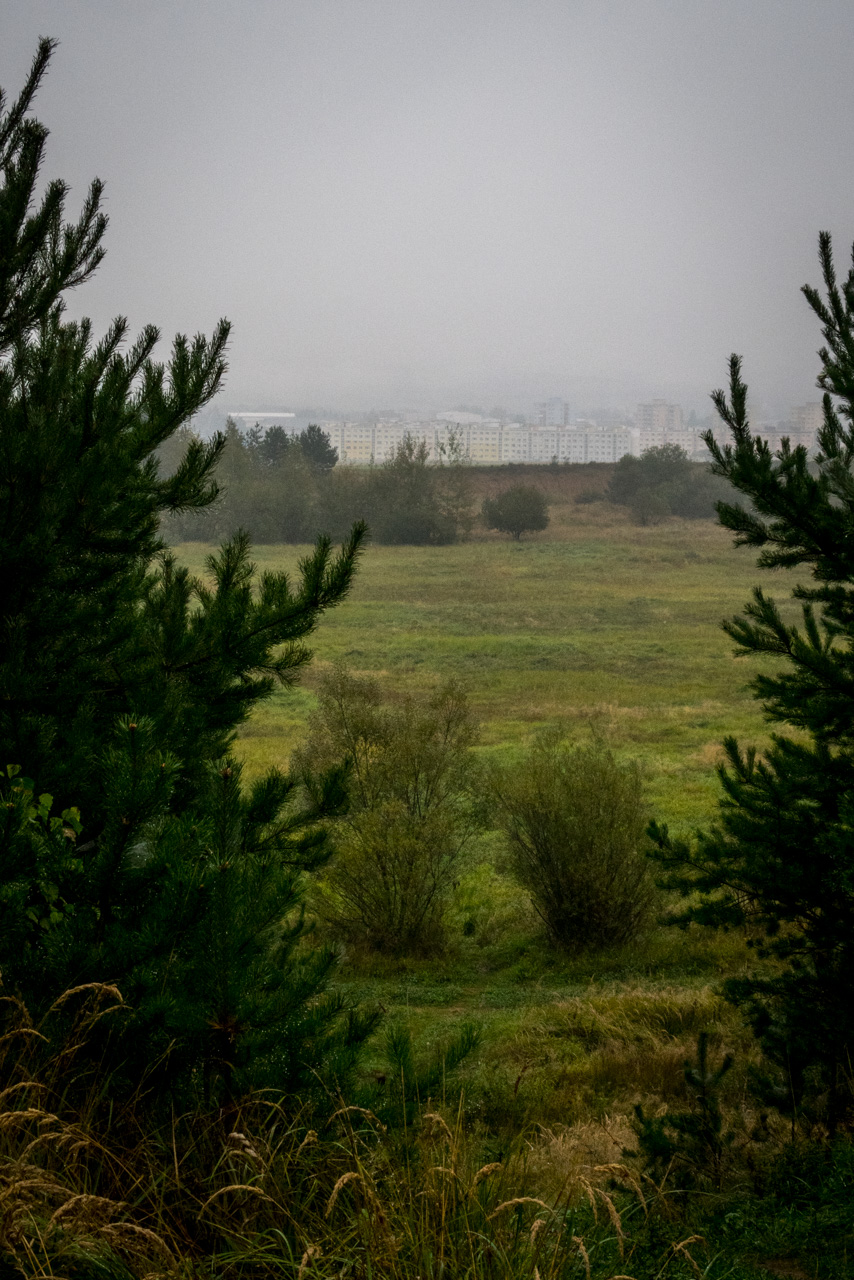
[626,1032,734,1188]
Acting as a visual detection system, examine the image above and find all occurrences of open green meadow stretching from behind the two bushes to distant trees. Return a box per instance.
[178,504,804,827]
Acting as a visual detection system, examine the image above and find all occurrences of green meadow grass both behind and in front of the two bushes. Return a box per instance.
[169,488,809,1158]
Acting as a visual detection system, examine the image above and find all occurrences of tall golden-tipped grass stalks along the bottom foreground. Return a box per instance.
[0,984,727,1280]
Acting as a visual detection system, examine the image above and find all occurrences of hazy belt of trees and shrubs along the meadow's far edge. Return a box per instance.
[160,419,730,545]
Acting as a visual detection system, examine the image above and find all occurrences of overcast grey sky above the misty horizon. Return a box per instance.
[0,0,854,413]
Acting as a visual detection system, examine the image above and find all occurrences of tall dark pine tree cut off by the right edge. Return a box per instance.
[654,233,854,1128]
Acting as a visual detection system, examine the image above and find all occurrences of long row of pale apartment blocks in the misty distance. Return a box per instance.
[233,401,822,466]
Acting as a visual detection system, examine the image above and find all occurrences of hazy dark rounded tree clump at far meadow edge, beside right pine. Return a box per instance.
[606,444,731,525]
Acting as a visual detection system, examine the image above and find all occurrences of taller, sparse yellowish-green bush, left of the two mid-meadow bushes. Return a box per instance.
[294,667,476,954]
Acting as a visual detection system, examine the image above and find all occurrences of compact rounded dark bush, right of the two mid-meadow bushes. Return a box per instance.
[493,732,654,951]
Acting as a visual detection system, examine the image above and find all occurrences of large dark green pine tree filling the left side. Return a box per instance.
[0,41,369,1096]
